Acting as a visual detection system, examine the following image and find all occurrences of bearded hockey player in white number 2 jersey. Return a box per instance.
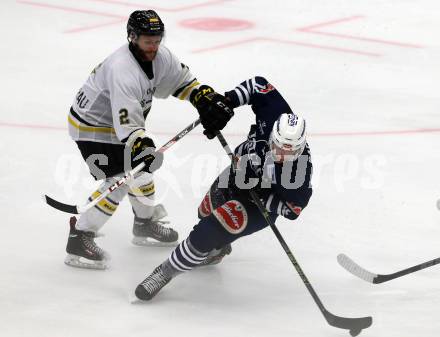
[65,10,233,269]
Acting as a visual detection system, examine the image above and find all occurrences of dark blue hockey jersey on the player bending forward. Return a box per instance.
[225,76,313,219]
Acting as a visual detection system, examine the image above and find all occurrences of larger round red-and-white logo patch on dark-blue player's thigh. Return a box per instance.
[213,200,248,234]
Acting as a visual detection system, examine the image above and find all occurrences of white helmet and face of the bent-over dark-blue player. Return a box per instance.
[269,113,306,162]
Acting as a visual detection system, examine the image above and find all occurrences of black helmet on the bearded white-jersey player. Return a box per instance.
[127,9,165,37]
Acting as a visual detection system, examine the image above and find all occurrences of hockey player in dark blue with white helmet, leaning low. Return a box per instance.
[135,77,312,300]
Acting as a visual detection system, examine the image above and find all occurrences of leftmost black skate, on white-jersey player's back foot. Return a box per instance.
[64,217,109,269]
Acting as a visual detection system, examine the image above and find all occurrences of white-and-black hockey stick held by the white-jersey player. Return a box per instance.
[44,119,200,214]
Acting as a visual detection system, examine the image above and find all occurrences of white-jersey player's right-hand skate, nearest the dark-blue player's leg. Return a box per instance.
[132,204,179,247]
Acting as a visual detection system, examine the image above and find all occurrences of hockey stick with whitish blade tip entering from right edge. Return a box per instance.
[338,254,440,284]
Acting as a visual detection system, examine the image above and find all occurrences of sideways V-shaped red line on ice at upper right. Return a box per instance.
[296,15,423,48]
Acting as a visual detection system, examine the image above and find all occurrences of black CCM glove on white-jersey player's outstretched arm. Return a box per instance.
[190,85,234,139]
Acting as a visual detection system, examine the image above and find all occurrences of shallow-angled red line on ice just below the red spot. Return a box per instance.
[192,37,382,57]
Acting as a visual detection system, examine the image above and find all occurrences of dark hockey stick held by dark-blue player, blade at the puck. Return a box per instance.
[217,132,373,336]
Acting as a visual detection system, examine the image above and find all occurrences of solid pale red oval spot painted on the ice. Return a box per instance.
[180,18,254,32]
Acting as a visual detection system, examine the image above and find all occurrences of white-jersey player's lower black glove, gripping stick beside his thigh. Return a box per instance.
[131,137,163,173]
